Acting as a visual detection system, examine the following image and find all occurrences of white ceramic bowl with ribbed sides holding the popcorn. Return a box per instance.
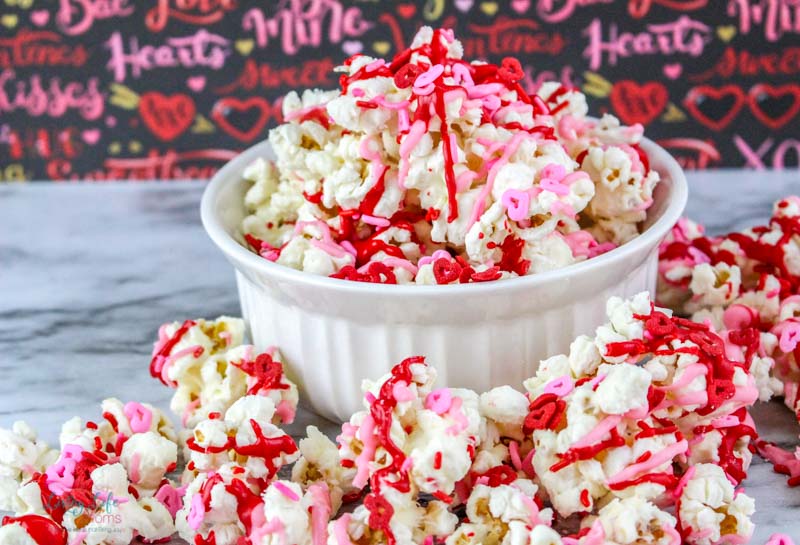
[201,139,688,420]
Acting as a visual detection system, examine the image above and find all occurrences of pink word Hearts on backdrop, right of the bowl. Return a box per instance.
[583,15,711,70]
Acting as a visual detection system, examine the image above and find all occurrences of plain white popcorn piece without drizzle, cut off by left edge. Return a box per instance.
[0,421,58,511]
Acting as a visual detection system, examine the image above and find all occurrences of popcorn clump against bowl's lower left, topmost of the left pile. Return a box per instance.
[150,316,298,428]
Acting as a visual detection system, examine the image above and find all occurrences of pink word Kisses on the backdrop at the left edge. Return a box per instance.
[0,70,105,120]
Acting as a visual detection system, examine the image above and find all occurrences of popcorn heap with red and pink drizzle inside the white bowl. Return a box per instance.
[242,27,659,284]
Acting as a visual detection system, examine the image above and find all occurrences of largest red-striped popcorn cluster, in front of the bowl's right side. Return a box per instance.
[523,294,758,516]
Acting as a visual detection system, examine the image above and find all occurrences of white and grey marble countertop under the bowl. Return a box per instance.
[0,171,800,545]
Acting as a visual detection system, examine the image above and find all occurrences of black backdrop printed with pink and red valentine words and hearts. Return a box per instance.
[0,0,800,181]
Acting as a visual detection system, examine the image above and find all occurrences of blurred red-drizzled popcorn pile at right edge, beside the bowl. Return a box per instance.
[658,196,800,485]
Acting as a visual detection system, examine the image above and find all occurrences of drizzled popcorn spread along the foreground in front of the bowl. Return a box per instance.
[0,294,780,545]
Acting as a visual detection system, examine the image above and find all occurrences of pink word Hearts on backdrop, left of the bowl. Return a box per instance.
[106,29,231,82]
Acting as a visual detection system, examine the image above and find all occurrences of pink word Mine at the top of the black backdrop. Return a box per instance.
[242,0,372,55]
